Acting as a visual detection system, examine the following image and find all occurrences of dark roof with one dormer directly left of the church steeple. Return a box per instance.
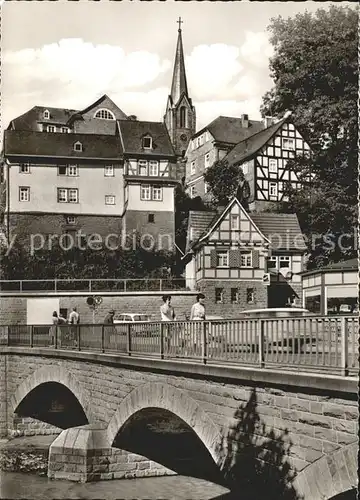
[117,120,175,156]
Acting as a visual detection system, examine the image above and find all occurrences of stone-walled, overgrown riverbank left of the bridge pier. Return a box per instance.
[0,434,57,477]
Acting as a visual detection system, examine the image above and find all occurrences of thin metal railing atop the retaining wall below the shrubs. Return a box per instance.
[0,278,196,293]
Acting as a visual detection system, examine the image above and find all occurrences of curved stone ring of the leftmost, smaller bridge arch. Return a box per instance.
[10,365,95,422]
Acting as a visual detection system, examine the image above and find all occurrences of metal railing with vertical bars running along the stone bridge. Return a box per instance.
[0,316,359,376]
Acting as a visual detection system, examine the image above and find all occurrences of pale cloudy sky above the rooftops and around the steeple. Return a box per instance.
[1,0,347,130]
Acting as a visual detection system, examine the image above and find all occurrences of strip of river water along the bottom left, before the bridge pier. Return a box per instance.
[0,472,228,500]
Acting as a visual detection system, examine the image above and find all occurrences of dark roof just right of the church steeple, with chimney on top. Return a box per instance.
[195,116,264,144]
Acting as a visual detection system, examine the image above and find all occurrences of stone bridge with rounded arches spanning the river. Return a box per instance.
[0,346,358,500]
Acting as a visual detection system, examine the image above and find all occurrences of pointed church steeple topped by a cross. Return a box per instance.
[164,18,196,157]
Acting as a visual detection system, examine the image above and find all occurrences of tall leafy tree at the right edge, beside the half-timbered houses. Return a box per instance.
[261,6,358,268]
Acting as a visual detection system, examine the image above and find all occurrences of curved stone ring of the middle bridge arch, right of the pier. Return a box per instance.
[107,383,221,465]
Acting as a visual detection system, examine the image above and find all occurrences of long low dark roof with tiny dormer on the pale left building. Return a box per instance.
[4,130,122,159]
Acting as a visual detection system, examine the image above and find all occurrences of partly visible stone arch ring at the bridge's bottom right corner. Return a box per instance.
[293,441,358,500]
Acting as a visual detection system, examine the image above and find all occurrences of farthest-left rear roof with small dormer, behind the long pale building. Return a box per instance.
[10,106,76,131]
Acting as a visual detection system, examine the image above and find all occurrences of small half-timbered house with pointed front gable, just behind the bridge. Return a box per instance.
[184,198,306,317]
